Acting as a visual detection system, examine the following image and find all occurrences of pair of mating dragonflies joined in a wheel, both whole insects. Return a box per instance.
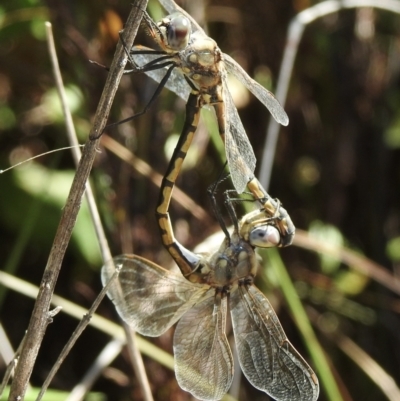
[102,0,319,401]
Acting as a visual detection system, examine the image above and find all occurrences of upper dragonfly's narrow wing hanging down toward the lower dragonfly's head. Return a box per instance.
[223,80,256,194]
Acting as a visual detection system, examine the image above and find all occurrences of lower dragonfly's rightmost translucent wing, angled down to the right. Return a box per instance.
[231,286,319,401]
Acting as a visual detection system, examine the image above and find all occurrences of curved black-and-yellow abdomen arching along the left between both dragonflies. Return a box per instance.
[156,92,205,277]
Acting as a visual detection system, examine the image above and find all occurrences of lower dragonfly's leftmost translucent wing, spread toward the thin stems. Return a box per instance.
[101,255,210,336]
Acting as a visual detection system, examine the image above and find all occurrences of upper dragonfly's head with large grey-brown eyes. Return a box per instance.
[158,13,192,52]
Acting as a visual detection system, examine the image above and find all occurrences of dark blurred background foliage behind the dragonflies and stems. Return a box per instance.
[0,0,400,400]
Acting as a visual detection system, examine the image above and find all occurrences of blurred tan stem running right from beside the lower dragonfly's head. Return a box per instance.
[293,229,400,295]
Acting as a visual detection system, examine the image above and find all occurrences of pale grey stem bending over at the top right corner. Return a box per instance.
[259,0,400,191]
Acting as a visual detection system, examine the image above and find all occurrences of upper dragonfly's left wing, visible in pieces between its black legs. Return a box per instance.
[133,46,190,102]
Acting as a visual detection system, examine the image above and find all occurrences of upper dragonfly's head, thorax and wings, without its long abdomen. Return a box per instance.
[124,0,289,193]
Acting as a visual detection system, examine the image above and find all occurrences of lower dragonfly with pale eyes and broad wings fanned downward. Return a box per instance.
[102,173,319,401]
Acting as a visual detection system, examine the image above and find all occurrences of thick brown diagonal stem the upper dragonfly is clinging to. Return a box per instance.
[9,0,147,401]
